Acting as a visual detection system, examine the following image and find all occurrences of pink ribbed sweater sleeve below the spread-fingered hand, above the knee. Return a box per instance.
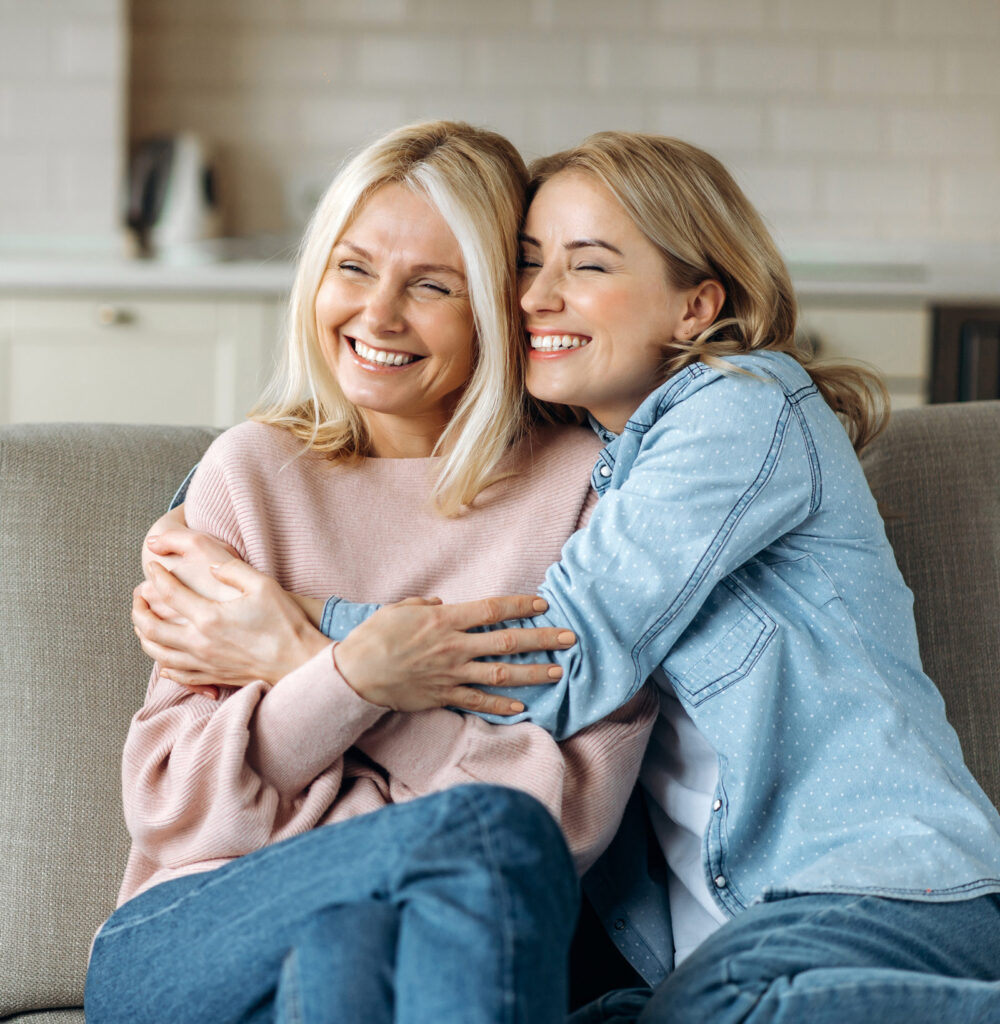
[357,685,659,873]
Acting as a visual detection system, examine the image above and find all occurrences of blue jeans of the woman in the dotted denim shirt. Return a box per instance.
[571,895,1000,1024]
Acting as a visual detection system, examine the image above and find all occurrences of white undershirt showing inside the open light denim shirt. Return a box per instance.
[639,670,727,966]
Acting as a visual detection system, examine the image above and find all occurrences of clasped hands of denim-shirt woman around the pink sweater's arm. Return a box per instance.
[132,529,330,688]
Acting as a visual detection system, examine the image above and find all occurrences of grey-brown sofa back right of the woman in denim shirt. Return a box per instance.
[862,401,1000,804]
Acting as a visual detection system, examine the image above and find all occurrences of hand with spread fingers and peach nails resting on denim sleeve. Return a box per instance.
[334,595,576,715]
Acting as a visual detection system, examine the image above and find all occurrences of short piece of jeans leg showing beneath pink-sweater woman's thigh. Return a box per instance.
[274,900,399,1024]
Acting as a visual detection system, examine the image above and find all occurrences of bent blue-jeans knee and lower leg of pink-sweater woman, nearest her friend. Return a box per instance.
[395,785,578,1024]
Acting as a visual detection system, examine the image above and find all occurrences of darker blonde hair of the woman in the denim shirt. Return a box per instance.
[528,131,888,452]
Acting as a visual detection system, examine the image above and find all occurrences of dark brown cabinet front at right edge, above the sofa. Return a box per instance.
[930,305,1000,402]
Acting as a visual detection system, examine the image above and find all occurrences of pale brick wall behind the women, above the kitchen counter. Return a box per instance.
[0,0,1000,242]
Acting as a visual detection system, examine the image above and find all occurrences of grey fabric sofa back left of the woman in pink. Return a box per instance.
[0,424,217,1019]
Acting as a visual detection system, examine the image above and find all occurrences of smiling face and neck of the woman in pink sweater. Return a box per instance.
[315,184,475,458]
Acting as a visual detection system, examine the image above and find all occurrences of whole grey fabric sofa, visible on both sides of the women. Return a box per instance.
[0,401,1000,1024]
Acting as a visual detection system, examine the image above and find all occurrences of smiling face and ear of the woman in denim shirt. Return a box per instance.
[521,170,721,433]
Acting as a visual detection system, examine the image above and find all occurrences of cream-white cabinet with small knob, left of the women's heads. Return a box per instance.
[0,293,284,426]
